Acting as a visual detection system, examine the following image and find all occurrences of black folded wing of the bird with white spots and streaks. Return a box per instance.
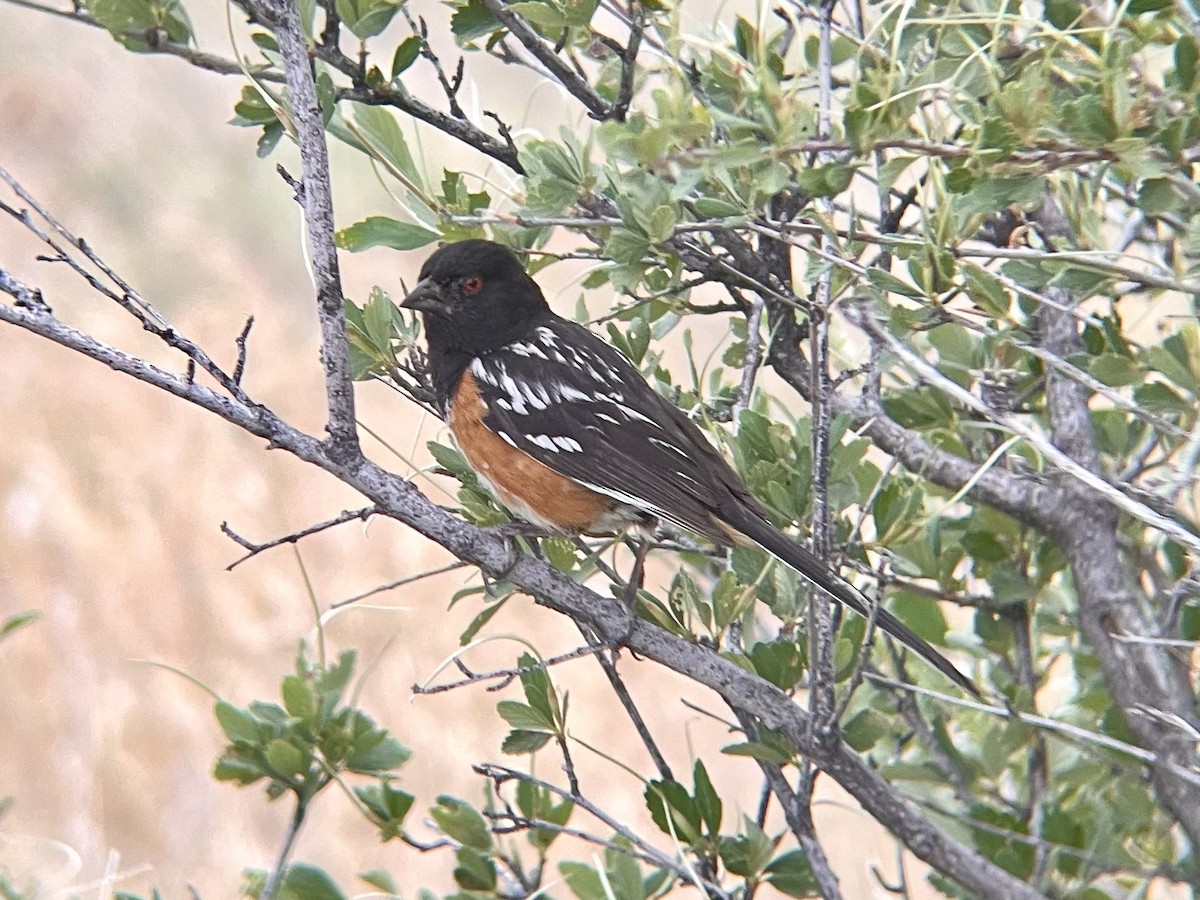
[470,317,757,544]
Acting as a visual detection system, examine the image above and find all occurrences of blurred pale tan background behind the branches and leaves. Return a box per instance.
[0,2,924,898]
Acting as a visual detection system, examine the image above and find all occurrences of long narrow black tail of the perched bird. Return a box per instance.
[730,511,982,698]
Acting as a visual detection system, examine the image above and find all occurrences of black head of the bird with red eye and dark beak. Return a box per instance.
[401,240,550,356]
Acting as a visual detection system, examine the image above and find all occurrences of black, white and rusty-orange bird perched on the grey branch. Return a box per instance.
[401,239,979,696]
